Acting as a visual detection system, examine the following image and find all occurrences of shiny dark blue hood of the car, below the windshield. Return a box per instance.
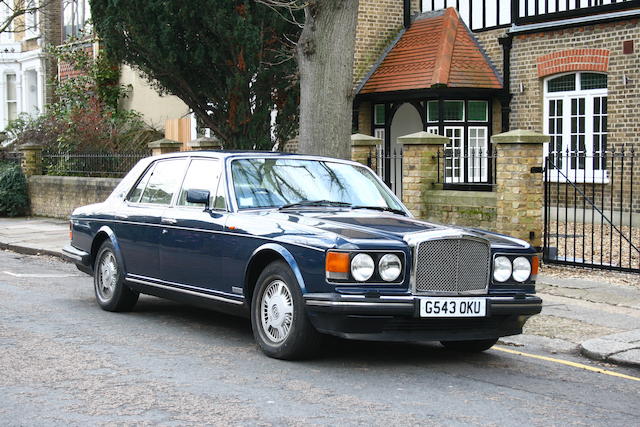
[255,209,530,248]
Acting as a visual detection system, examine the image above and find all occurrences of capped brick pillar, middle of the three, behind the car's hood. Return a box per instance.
[398,132,449,218]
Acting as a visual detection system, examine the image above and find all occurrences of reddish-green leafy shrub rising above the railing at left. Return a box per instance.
[6,43,162,153]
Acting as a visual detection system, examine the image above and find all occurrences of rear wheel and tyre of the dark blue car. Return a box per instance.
[93,240,139,311]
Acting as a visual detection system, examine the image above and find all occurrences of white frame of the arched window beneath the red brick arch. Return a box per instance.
[543,71,609,184]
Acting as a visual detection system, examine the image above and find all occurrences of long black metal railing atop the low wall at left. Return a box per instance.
[42,151,151,178]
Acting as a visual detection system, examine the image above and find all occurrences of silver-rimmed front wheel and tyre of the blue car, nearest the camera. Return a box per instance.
[251,261,321,360]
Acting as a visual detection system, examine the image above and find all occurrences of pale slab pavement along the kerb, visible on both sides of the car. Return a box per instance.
[0,217,640,368]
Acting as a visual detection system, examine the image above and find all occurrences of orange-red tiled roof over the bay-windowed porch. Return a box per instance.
[358,8,502,94]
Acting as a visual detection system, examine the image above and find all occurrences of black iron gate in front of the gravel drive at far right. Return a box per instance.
[543,148,640,272]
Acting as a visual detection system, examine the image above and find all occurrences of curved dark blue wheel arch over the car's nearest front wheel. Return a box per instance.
[243,243,306,305]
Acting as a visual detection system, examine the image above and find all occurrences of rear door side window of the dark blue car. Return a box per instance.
[134,159,187,205]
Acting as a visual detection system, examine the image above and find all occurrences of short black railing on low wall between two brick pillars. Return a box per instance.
[436,147,497,191]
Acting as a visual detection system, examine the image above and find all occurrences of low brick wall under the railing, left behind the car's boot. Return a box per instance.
[29,175,120,218]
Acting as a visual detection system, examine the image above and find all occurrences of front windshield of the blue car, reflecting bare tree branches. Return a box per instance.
[231,158,404,212]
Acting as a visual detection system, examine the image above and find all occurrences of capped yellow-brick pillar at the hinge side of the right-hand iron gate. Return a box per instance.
[491,129,549,248]
